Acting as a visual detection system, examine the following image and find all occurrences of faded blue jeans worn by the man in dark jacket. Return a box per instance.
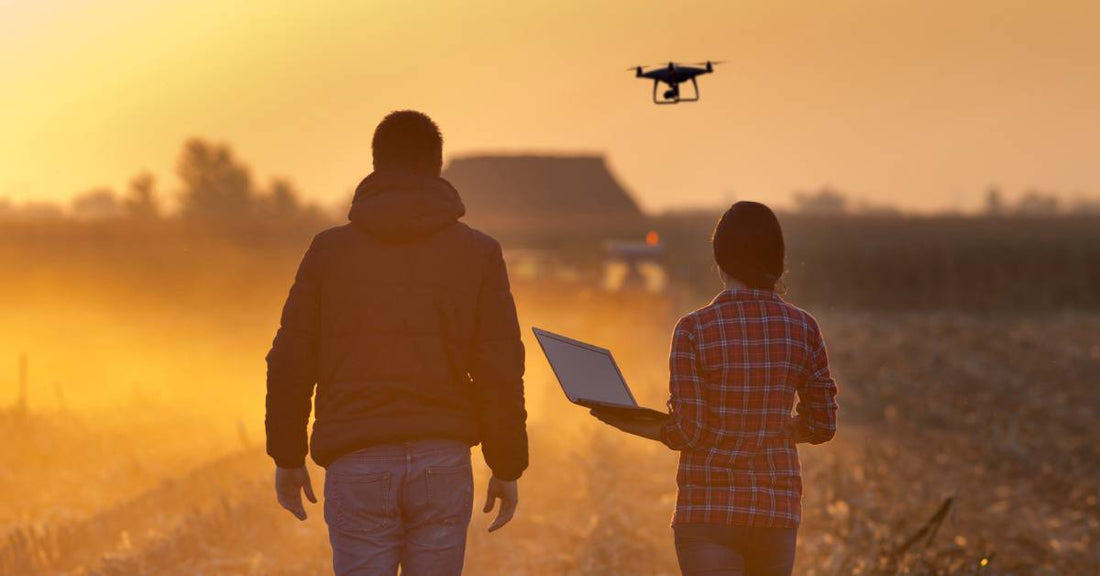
[325,440,474,576]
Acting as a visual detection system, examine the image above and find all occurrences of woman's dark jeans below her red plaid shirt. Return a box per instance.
[672,524,799,576]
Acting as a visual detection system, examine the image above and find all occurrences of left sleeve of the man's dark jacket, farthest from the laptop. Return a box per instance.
[264,239,321,468]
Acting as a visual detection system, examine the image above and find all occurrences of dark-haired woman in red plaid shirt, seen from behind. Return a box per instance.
[593,202,837,576]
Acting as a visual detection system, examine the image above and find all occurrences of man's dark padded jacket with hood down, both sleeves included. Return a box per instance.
[265,171,527,480]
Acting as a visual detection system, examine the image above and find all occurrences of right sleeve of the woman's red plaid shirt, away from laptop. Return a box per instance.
[794,324,837,444]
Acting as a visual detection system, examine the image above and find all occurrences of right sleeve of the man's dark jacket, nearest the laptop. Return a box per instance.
[470,242,528,480]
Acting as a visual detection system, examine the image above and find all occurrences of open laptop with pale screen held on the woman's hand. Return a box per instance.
[531,328,668,420]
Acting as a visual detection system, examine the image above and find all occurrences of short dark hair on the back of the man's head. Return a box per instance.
[371,110,443,176]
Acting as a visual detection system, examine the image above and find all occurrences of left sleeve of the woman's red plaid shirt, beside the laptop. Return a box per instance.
[661,318,706,451]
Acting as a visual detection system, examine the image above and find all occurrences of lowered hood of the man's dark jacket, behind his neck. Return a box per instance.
[348,170,466,242]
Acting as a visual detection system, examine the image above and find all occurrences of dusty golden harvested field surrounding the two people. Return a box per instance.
[0,217,1100,576]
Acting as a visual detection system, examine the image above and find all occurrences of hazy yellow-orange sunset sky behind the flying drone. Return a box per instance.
[0,0,1100,210]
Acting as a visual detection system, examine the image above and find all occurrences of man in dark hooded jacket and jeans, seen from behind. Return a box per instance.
[266,111,527,576]
